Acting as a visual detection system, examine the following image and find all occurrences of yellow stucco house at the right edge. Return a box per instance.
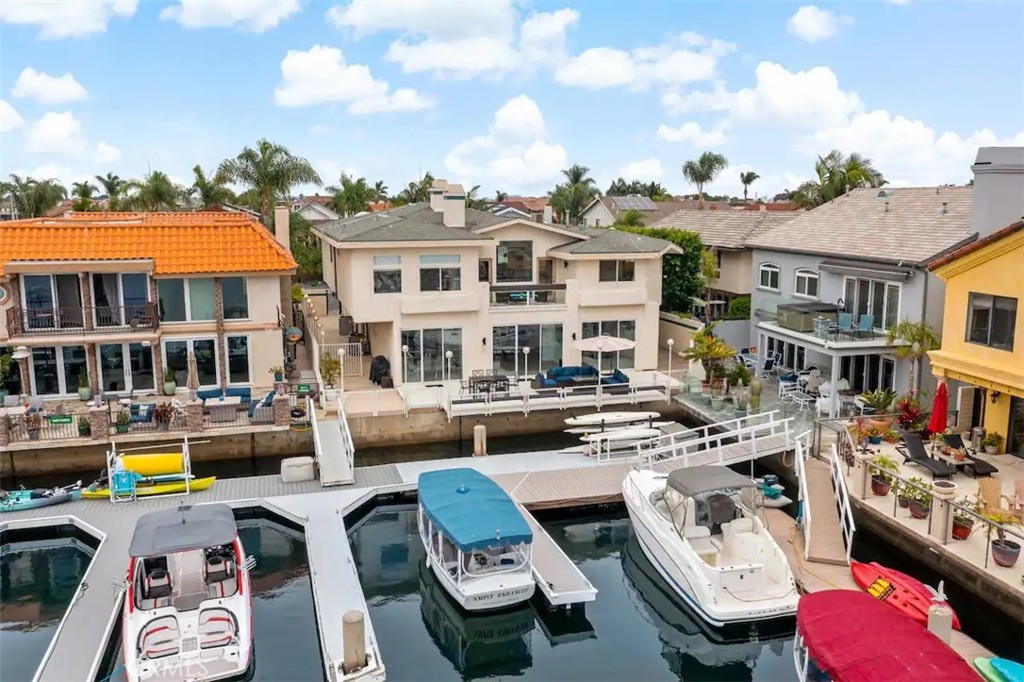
[929,220,1024,457]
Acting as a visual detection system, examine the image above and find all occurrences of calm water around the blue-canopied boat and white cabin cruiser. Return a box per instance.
[349,507,794,682]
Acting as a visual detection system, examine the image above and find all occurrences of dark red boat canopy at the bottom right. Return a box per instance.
[797,590,978,682]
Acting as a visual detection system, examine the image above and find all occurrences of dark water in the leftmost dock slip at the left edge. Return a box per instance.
[0,539,92,682]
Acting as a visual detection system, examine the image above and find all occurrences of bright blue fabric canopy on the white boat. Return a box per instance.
[419,469,534,552]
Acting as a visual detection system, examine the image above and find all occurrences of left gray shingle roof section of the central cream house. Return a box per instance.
[315,203,508,242]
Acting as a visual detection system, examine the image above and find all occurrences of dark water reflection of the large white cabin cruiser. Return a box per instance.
[622,536,796,682]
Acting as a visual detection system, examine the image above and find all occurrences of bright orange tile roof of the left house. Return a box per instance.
[0,212,296,275]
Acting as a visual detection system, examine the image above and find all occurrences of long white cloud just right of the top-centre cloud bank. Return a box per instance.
[555,32,736,90]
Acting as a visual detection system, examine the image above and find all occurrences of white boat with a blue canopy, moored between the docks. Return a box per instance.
[417,469,537,611]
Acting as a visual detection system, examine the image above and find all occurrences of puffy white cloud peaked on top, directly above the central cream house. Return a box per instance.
[444,95,568,187]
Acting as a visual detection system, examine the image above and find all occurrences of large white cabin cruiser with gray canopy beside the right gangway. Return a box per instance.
[623,466,800,627]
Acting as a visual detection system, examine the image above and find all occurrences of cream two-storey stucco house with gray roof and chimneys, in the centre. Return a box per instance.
[313,180,679,383]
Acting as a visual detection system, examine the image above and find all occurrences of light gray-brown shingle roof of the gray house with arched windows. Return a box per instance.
[746,186,973,263]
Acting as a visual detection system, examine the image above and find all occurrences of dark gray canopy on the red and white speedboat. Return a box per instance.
[128,505,237,557]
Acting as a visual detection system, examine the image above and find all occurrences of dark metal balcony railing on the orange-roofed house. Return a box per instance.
[7,303,159,337]
